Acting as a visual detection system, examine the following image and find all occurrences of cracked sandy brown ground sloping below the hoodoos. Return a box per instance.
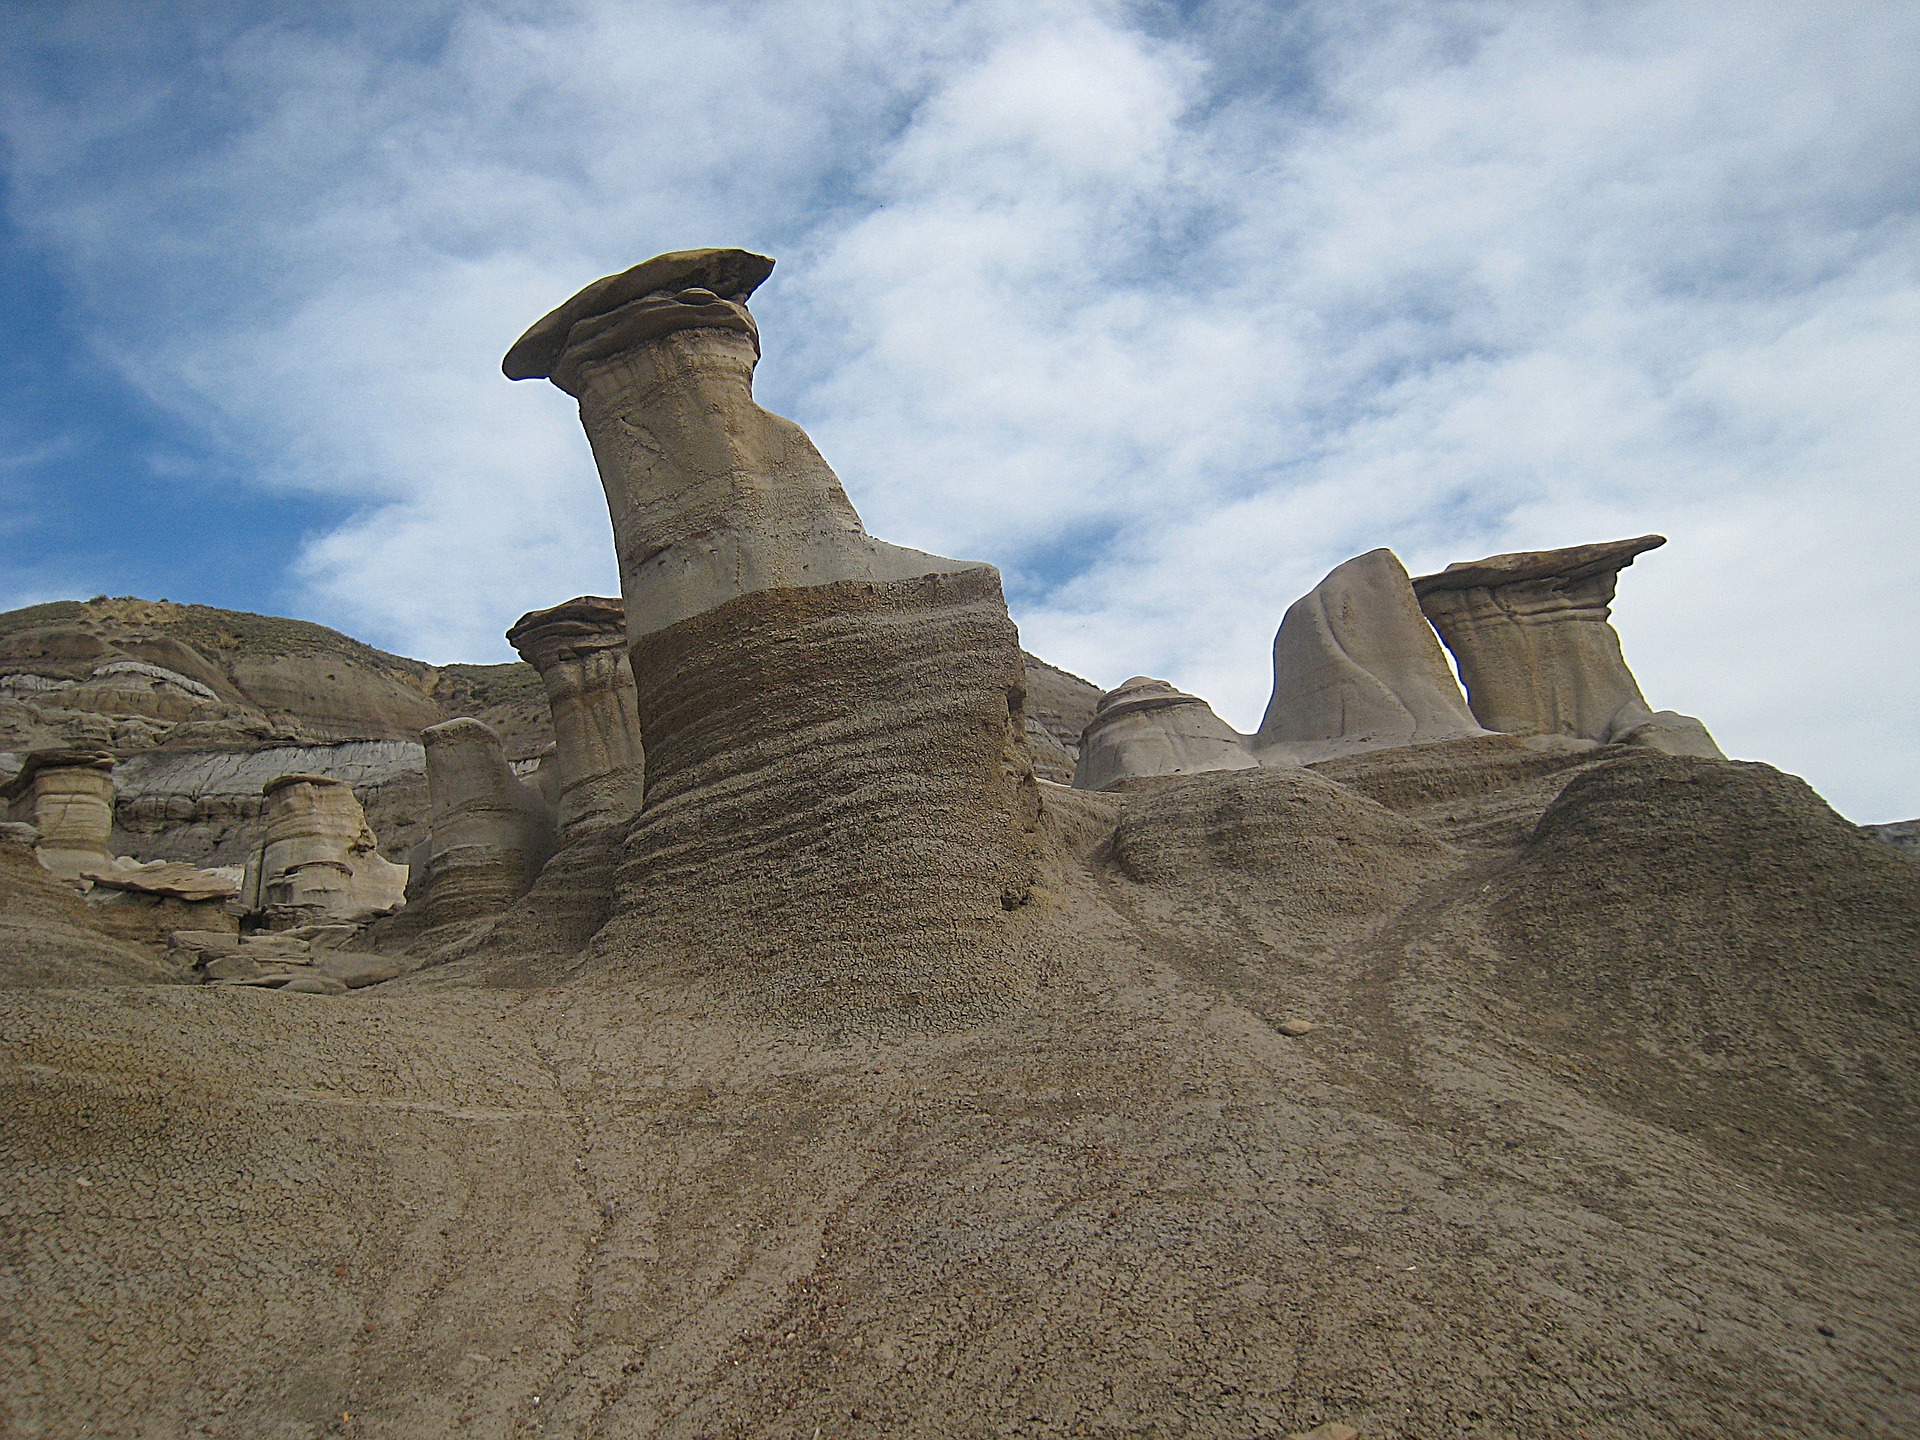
[0,737,1920,1440]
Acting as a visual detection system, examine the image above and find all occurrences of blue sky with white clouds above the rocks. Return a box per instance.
[0,0,1920,822]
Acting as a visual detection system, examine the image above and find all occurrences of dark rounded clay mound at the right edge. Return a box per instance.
[1492,753,1920,1185]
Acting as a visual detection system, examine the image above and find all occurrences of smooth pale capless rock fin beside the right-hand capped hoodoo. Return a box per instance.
[1254,549,1486,764]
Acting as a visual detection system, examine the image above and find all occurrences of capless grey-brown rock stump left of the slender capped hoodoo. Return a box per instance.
[409,720,553,925]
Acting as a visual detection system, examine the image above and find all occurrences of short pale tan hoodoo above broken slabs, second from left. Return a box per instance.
[240,774,407,924]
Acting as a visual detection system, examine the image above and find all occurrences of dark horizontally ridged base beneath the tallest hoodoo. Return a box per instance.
[595,566,1039,1014]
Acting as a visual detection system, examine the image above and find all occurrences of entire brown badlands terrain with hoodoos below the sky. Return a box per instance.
[0,250,1920,1440]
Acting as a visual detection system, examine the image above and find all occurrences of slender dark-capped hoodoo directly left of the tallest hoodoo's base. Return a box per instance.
[507,595,643,845]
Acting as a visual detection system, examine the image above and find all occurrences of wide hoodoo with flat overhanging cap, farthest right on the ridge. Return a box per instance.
[1413,536,1720,756]
